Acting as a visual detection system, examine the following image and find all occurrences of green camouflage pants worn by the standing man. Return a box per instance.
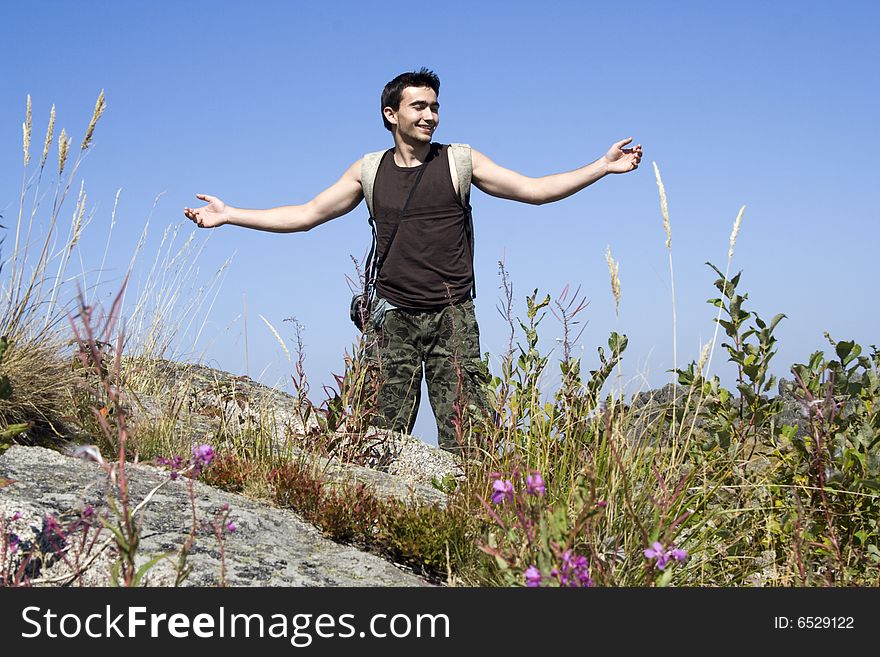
[371,299,489,452]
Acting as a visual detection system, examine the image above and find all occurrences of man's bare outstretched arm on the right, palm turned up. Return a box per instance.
[471,138,642,205]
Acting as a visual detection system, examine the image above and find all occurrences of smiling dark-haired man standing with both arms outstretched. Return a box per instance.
[184,68,642,451]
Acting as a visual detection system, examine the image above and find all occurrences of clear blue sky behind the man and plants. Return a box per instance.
[0,0,880,442]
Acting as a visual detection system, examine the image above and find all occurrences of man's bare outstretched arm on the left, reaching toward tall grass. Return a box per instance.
[183,160,364,233]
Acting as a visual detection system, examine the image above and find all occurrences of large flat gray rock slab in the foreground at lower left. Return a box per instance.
[0,446,434,586]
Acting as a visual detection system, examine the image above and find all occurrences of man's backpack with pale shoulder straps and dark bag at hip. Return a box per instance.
[350,144,477,330]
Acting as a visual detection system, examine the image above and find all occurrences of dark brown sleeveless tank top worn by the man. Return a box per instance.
[373,144,474,308]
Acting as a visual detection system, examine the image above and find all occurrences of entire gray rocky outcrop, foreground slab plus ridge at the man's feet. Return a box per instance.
[0,360,462,586]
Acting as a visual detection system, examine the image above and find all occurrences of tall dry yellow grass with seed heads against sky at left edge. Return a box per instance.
[0,91,231,452]
